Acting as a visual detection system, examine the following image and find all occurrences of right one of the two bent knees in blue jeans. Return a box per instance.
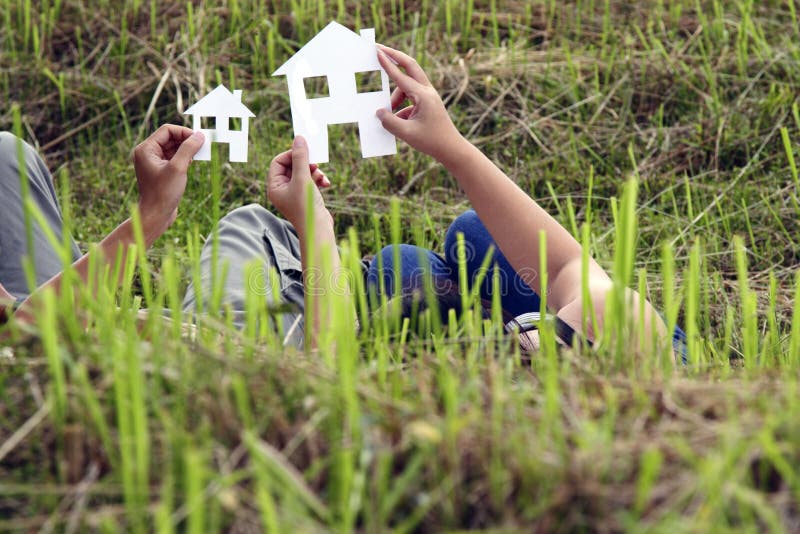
[444,210,539,316]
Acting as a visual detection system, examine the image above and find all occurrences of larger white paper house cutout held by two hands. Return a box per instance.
[272,22,397,163]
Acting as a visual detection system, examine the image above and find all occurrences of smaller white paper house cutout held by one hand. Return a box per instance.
[184,85,255,162]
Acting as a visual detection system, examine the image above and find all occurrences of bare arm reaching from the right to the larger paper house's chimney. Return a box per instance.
[378,45,664,348]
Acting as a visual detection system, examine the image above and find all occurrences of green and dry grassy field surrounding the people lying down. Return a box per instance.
[0,0,800,533]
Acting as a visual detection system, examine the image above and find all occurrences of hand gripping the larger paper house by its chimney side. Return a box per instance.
[377,44,464,161]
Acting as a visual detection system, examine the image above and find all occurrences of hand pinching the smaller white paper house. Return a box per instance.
[133,124,204,241]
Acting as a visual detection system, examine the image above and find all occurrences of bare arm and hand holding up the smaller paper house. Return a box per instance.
[6,125,203,322]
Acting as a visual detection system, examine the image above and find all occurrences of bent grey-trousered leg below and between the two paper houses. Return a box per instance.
[183,204,304,348]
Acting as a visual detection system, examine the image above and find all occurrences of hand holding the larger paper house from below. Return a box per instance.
[267,135,333,233]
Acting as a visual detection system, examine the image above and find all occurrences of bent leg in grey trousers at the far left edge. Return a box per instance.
[0,132,80,297]
